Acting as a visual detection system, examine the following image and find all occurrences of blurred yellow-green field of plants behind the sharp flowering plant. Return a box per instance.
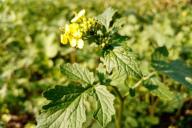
[0,0,192,128]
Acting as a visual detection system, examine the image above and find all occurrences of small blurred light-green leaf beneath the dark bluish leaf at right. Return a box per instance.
[144,78,174,100]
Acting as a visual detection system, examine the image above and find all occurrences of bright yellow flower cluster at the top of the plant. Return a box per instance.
[61,10,96,49]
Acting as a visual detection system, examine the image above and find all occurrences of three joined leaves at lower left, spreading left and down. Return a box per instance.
[37,64,115,128]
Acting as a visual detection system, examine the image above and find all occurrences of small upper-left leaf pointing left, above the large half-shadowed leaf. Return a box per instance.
[61,64,94,84]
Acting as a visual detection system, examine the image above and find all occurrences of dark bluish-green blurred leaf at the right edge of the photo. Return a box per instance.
[152,46,192,89]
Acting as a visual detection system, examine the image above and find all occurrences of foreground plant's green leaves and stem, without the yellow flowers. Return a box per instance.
[38,8,191,128]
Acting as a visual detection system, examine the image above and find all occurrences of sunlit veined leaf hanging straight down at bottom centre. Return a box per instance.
[94,85,115,127]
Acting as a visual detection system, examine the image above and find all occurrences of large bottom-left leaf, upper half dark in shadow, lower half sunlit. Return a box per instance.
[37,86,90,128]
